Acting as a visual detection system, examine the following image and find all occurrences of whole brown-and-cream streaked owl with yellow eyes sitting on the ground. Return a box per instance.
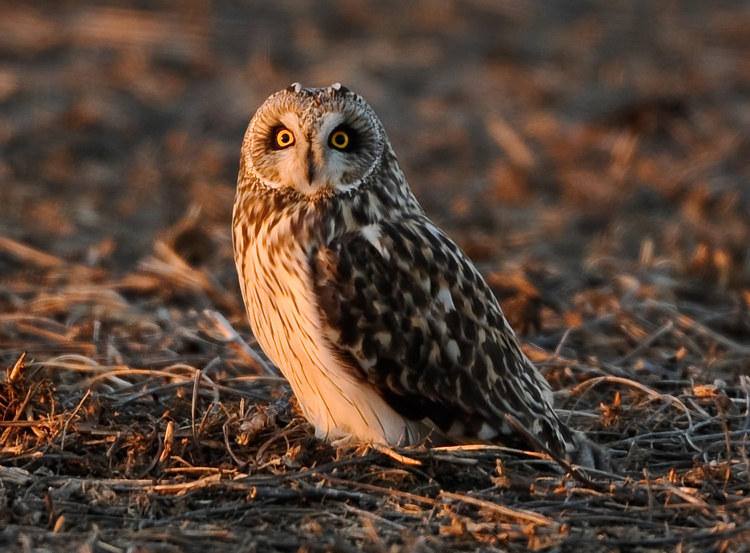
[233,83,605,467]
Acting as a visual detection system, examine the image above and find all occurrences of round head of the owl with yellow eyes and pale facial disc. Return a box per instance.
[242,83,387,198]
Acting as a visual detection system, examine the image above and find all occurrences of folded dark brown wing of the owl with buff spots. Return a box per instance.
[311,216,574,458]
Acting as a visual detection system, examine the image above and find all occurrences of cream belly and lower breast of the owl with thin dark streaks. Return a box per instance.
[235,213,417,444]
